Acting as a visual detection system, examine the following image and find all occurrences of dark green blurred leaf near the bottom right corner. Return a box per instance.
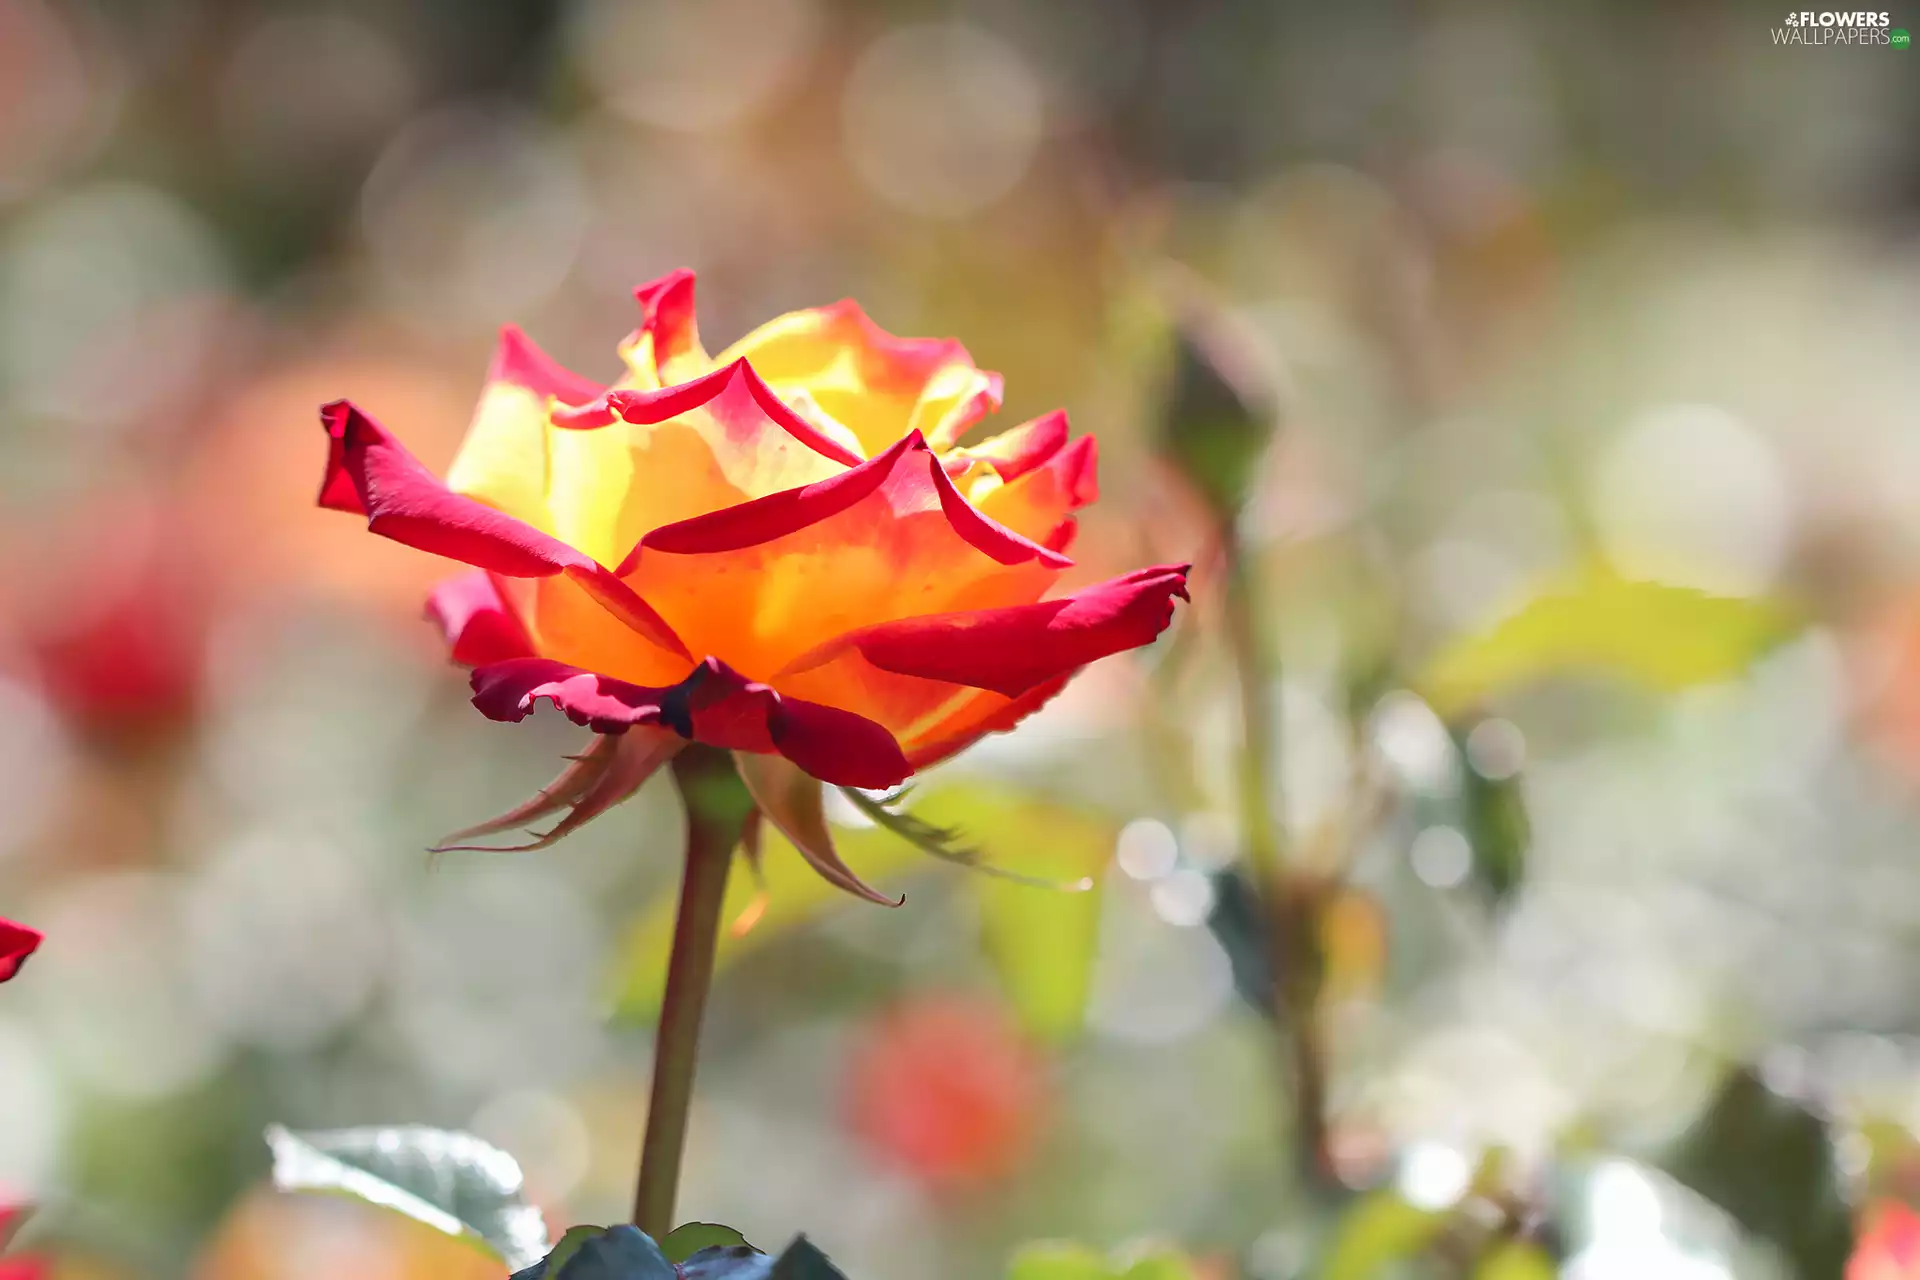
[1667,1069,1853,1280]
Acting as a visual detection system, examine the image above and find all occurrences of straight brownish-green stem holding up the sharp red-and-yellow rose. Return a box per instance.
[634,745,753,1240]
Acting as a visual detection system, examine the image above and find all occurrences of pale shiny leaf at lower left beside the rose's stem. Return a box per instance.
[267,1125,549,1270]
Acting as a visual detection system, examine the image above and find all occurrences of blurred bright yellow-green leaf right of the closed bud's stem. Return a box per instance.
[1417,564,1797,718]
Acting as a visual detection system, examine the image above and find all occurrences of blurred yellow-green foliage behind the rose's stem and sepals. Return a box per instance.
[616,783,1116,1036]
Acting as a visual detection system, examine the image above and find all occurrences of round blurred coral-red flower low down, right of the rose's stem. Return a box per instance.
[847,996,1046,1192]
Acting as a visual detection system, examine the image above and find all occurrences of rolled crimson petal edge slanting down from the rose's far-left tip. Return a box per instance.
[321,401,687,666]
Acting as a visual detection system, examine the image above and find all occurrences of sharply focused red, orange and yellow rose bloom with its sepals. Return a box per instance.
[321,271,1187,896]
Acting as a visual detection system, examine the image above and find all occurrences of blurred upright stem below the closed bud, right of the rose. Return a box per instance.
[1221,524,1338,1188]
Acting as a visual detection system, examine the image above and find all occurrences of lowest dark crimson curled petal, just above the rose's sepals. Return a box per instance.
[472,658,910,787]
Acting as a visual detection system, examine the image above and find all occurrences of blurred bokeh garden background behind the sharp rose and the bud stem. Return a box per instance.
[0,0,1920,1280]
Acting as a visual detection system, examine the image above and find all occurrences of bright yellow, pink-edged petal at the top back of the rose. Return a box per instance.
[718,299,1000,457]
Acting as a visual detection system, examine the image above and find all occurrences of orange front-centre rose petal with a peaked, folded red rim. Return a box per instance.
[620,436,1069,677]
